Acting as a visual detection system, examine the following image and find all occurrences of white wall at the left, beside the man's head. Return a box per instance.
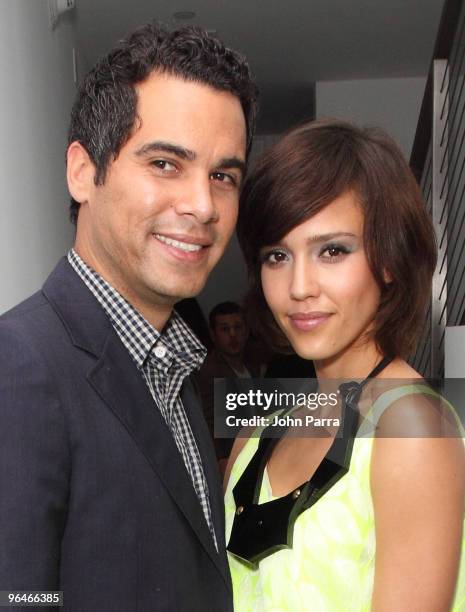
[0,0,75,313]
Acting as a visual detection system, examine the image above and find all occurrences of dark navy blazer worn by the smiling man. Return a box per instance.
[0,259,232,612]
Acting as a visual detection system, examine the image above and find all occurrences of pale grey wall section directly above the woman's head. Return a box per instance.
[315,77,426,159]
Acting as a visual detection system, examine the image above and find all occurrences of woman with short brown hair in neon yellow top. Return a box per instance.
[226,121,465,612]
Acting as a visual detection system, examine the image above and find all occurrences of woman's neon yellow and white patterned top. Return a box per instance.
[225,385,465,612]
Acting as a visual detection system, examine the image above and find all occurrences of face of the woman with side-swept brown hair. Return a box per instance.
[261,191,380,361]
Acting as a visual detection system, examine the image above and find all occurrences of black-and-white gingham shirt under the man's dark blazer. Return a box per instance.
[68,249,218,550]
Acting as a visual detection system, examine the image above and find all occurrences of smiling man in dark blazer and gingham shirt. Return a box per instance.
[0,24,256,612]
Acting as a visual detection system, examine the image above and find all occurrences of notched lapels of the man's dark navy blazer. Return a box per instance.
[42,258,231,589]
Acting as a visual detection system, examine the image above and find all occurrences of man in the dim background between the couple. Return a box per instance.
[198,302,261,473]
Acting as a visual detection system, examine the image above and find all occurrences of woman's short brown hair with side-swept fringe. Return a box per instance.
[237,120,437,357]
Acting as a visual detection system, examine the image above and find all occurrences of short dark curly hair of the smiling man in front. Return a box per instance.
[68,22,257,223]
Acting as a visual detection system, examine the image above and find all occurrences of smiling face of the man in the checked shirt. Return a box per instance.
[70,73,246,318]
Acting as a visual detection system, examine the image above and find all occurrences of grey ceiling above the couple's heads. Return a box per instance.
[76,0,443,133]
